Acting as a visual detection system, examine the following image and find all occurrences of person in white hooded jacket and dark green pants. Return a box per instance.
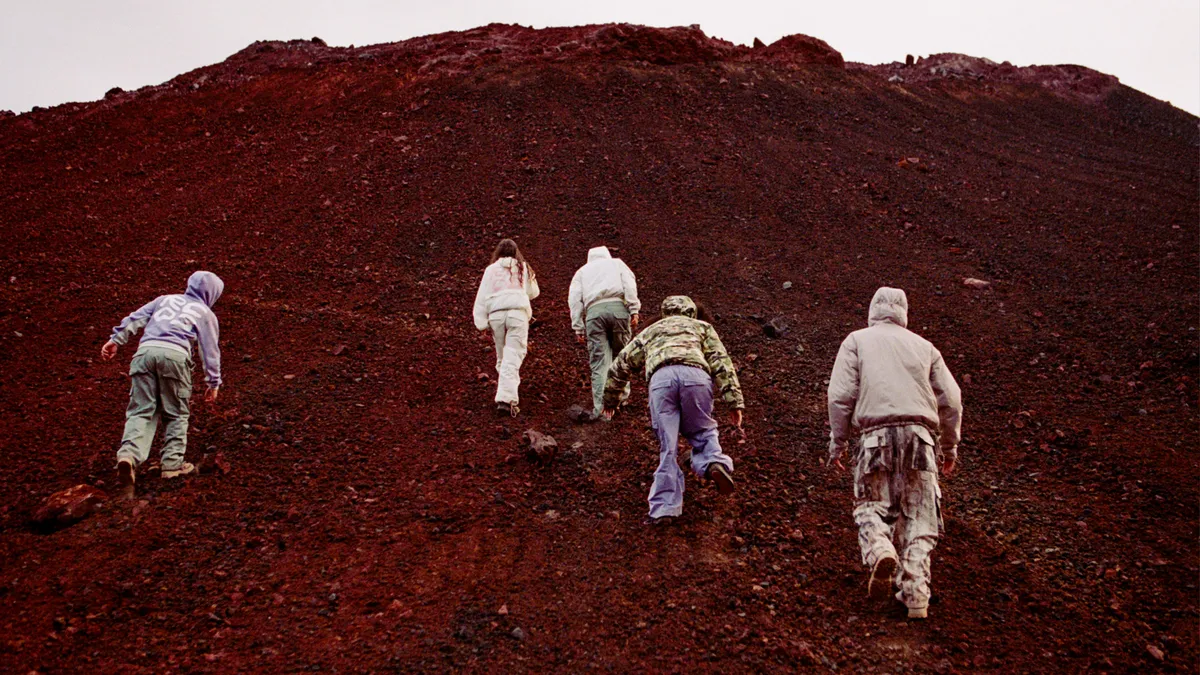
[566,246,642,419]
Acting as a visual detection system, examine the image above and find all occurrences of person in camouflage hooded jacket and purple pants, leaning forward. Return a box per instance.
[604,295,745,524]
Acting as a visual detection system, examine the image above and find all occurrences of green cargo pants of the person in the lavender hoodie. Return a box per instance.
[116,347,192,471]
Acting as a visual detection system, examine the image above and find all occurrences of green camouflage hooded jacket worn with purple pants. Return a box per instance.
[604,295,745,410]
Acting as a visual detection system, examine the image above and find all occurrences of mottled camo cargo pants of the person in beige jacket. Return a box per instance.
[854,425,942,608]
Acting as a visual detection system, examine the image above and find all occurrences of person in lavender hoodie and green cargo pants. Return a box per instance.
[100,271,224,486]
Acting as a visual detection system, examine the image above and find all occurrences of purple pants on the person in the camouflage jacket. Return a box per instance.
[650,365,733,518]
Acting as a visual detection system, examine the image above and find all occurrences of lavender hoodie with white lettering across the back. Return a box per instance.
[112,271,224,389]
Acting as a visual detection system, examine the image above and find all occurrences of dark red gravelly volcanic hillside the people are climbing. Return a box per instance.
[0,25,1200,673]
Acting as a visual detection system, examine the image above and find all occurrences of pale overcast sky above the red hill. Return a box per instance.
[0,0,1200,114]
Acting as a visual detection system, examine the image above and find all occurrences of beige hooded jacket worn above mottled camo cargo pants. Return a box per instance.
[829,287,962,460]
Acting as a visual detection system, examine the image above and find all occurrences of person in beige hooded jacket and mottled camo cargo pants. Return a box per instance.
[829,287,962,619]
